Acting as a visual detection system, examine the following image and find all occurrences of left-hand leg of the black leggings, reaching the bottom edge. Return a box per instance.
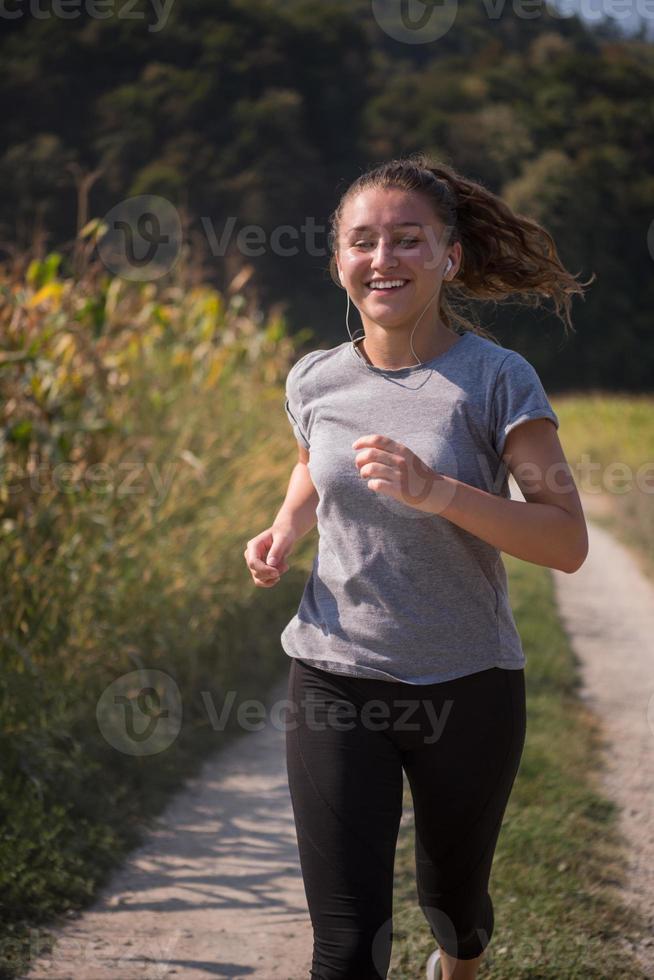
[286,659,403,980]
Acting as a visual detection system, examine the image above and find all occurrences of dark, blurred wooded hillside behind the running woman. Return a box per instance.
[0,0,654,391]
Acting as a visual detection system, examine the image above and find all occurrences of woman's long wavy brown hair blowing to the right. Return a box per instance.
[328,153,596,343]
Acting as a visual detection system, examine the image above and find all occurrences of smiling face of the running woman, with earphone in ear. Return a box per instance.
[336,188,461,329]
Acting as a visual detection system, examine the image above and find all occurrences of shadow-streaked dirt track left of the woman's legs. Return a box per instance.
[26,681,312,980]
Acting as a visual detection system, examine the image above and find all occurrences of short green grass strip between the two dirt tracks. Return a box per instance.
[389,556,645,980]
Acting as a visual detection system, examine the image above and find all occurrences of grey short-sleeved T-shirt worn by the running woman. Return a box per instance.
[281,332,559,684]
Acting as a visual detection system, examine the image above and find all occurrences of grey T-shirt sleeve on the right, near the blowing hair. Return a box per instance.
[490,351,559,458]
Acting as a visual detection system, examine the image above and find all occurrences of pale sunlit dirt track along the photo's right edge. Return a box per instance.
[553,490,654,977]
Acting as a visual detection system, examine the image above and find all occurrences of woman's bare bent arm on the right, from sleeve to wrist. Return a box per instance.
[427,418,588,573]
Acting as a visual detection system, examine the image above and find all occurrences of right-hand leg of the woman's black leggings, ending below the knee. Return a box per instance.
[403,667,526,959]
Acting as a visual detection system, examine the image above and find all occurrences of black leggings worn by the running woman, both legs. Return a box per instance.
[286,658,526,980]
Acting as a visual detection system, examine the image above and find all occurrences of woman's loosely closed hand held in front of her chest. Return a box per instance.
[352,434,440,514]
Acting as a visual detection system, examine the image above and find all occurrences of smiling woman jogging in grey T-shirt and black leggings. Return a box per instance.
[244,155,592,980]
